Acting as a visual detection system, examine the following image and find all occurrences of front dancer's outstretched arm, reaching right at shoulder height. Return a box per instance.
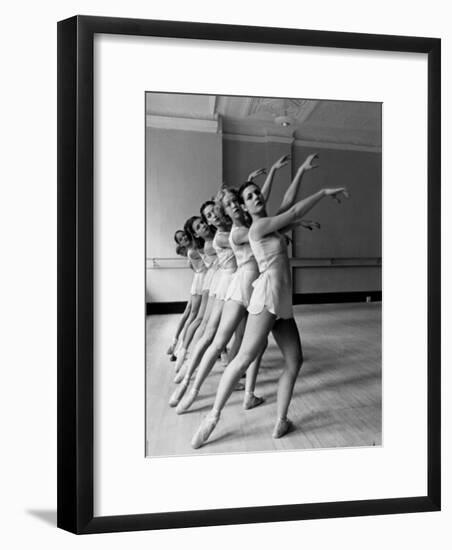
[250,187,348,240]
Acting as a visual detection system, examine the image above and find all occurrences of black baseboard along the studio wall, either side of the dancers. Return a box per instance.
[146,290,382,315]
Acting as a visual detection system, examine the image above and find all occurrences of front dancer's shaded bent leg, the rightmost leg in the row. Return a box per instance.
[272,319,303,438]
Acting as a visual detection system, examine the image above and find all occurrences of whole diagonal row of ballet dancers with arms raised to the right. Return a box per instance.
[164,154,348,449]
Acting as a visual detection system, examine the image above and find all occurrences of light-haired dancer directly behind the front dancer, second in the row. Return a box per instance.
[176,154,320,414]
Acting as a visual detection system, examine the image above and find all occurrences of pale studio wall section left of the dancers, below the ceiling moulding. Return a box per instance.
[146,126,222,302]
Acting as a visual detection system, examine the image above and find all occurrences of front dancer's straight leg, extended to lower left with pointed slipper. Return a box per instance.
[192,308,275,449]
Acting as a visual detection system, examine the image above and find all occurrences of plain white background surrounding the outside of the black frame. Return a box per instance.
[0,0,452,550]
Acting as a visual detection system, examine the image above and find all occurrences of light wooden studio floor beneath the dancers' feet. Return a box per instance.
[146,303,382,456]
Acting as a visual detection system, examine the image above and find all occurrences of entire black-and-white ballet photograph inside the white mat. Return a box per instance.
[144,91,384,458]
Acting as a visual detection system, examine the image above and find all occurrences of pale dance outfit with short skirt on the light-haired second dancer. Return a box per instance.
[226,226,259,307]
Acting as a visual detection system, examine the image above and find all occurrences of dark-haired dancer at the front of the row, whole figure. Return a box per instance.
[191,169,348,449]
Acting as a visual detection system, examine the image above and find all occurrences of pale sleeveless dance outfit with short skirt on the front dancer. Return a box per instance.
[248,232,293,319]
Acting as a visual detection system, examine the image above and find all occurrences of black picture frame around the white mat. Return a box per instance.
[58,16,441,534]
